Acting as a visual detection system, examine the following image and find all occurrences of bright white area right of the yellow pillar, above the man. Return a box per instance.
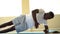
[30,0,60,14]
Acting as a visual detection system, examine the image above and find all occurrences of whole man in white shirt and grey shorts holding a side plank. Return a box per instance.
[0,9,54,33]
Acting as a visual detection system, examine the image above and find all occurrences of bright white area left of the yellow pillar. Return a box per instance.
[0,0,22,17]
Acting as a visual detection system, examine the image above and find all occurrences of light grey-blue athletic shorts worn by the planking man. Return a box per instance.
[13,15,28,32]
